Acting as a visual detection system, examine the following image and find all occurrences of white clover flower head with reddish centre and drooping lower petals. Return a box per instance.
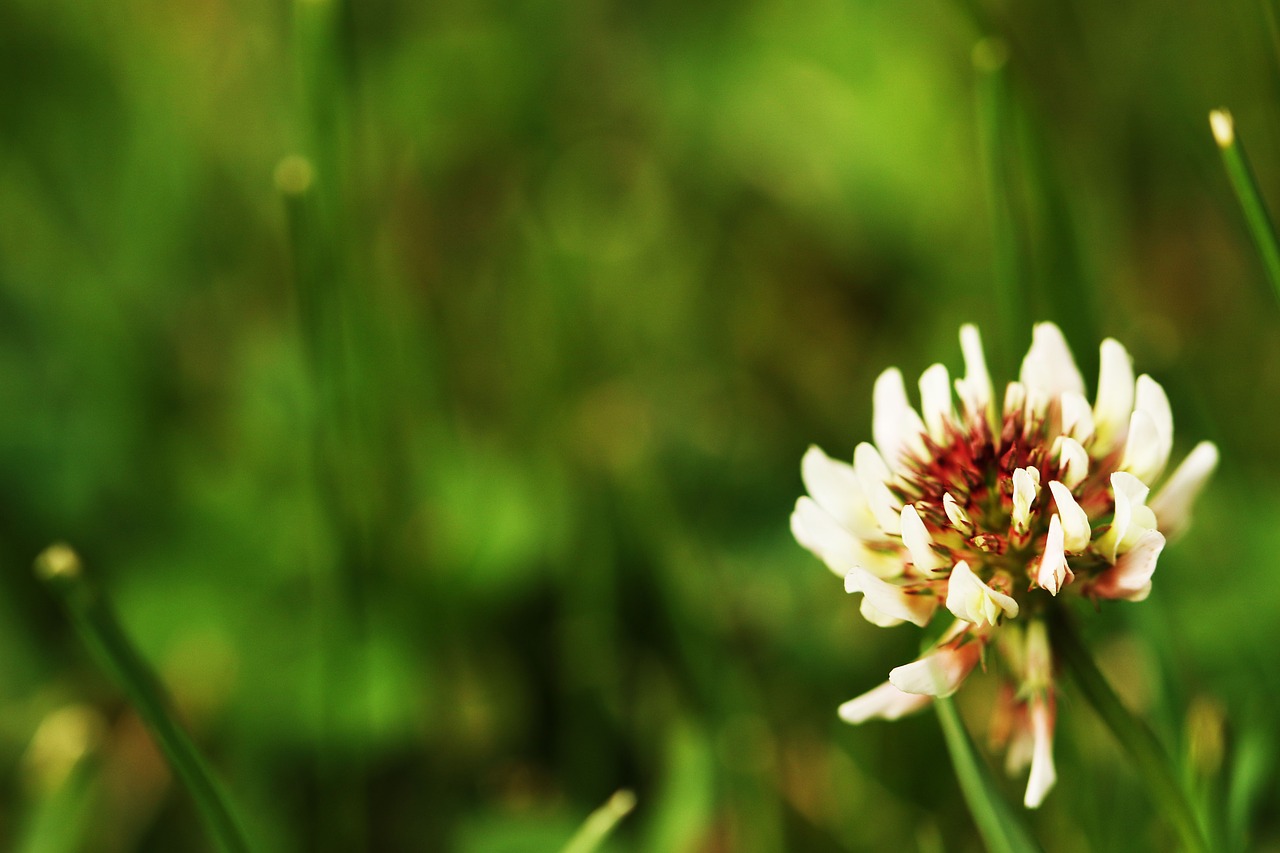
[791,323,1217,808]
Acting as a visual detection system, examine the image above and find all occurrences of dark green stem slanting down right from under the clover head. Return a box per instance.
[1051,608,1210,853]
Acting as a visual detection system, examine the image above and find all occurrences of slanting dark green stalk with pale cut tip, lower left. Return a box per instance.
[36,544,251,853]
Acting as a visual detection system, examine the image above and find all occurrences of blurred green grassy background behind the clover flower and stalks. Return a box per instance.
[0,0,1280,853]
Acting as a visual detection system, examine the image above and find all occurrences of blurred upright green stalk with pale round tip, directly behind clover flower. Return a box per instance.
[973,37,1030,368]
